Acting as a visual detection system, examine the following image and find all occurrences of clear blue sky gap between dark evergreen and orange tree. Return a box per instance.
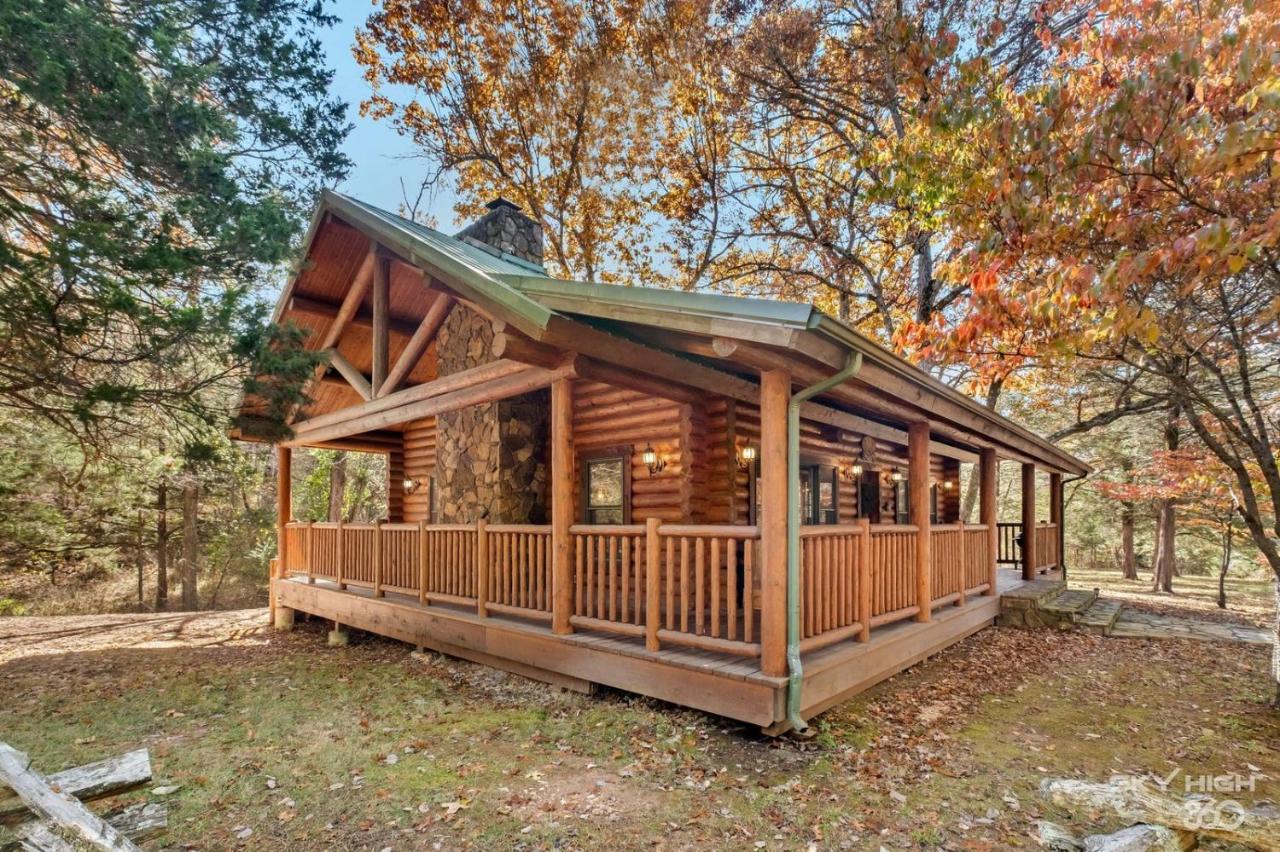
[321,0,458,225]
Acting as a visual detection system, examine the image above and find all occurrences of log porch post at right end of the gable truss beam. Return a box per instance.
[552,379,573,635]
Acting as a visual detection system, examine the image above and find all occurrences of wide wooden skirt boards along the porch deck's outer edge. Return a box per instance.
[276,569,1059,732]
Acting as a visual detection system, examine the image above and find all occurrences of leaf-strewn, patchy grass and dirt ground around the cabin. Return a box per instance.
[0,609,1280,851]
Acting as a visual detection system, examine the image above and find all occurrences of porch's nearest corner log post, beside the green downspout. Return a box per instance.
[760,370,791,678]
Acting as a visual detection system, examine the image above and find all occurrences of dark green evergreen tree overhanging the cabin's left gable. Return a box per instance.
[0,0,348,444]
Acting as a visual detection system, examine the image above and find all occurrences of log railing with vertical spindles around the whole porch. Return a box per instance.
[282,511,1008,658]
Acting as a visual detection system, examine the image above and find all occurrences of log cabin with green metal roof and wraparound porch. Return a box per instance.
[237,191,1089,733]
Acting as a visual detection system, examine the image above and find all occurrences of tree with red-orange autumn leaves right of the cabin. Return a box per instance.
[938,0,1280,700]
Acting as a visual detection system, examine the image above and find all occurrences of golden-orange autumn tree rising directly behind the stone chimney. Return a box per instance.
[353,0,705,280]
